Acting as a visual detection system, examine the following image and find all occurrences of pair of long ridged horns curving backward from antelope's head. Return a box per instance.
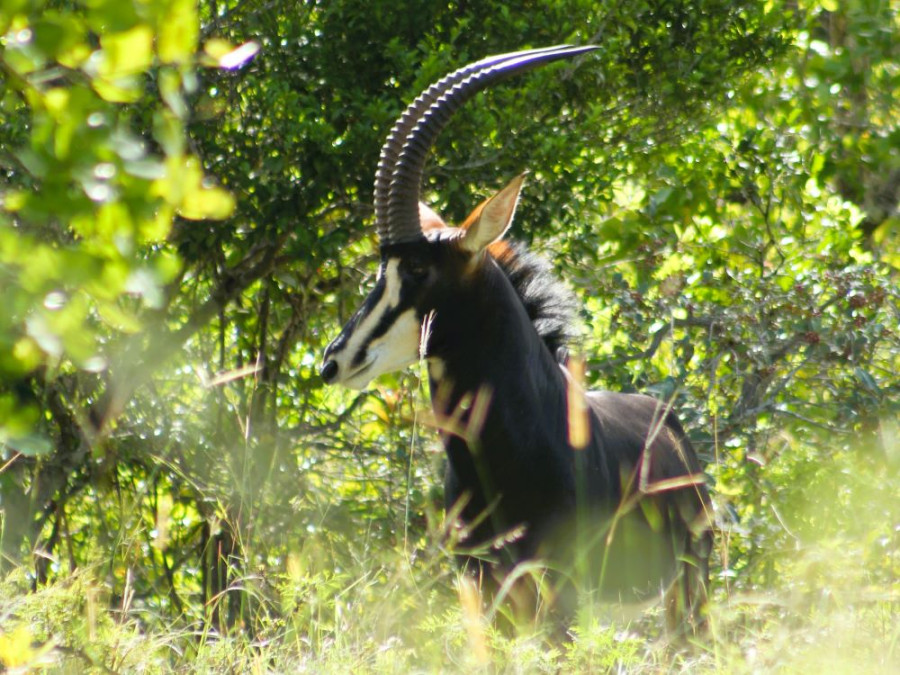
[375,45,597,246]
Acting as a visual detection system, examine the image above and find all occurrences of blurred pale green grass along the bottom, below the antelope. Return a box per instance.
[0,444,900,674]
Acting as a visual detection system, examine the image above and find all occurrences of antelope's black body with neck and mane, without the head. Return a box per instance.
[429,234,711,616]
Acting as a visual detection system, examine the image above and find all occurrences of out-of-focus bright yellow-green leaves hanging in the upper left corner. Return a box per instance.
[0,0,233,446]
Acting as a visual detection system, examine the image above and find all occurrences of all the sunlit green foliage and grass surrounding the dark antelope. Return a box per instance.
[0,0,900,673]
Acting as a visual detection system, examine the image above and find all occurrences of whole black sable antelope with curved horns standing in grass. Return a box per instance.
[321,45,712,623]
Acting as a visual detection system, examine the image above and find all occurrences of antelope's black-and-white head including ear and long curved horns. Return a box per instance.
[320,46,595,389]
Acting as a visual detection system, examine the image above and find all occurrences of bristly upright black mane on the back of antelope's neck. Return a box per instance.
[489,241,578,357]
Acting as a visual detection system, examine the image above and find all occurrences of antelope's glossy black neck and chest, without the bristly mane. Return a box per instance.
[429,268,576,556]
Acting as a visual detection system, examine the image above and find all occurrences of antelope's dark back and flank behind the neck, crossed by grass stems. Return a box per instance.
[554,391,712,601]
